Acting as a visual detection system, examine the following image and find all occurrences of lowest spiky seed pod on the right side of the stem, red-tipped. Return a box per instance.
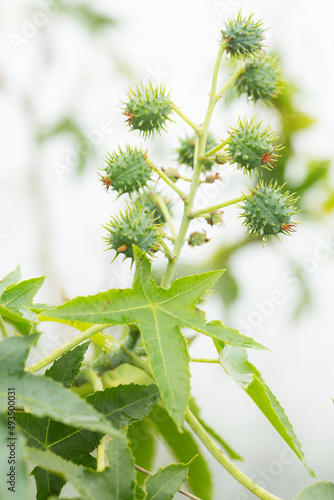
[240,181,297,246]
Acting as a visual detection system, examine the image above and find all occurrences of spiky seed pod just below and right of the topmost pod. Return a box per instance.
[236,56,283,102]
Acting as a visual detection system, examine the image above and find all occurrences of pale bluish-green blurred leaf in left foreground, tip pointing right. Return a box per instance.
[0,334,119,437]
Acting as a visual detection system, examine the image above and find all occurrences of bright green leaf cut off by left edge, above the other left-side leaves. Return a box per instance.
[0,269,45,335]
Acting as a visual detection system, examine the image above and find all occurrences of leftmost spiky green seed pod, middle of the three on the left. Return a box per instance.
[101,145,152,195]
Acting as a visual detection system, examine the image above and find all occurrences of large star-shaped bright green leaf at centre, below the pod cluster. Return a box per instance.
[41,247,264,429]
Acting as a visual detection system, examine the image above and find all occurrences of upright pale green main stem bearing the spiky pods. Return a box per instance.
[161,42,226,288]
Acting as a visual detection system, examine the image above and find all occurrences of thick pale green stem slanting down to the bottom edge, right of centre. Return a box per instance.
[186,410,282,500]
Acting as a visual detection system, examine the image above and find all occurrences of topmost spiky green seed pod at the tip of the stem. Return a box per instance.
[222,12,263,56]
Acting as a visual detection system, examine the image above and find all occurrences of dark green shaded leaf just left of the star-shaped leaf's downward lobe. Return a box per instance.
[86,384,160,429]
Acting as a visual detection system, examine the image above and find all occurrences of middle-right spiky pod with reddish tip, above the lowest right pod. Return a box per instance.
[225,117,279,176]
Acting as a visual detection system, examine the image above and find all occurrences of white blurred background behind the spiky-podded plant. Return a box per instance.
[0,0,334,500]
